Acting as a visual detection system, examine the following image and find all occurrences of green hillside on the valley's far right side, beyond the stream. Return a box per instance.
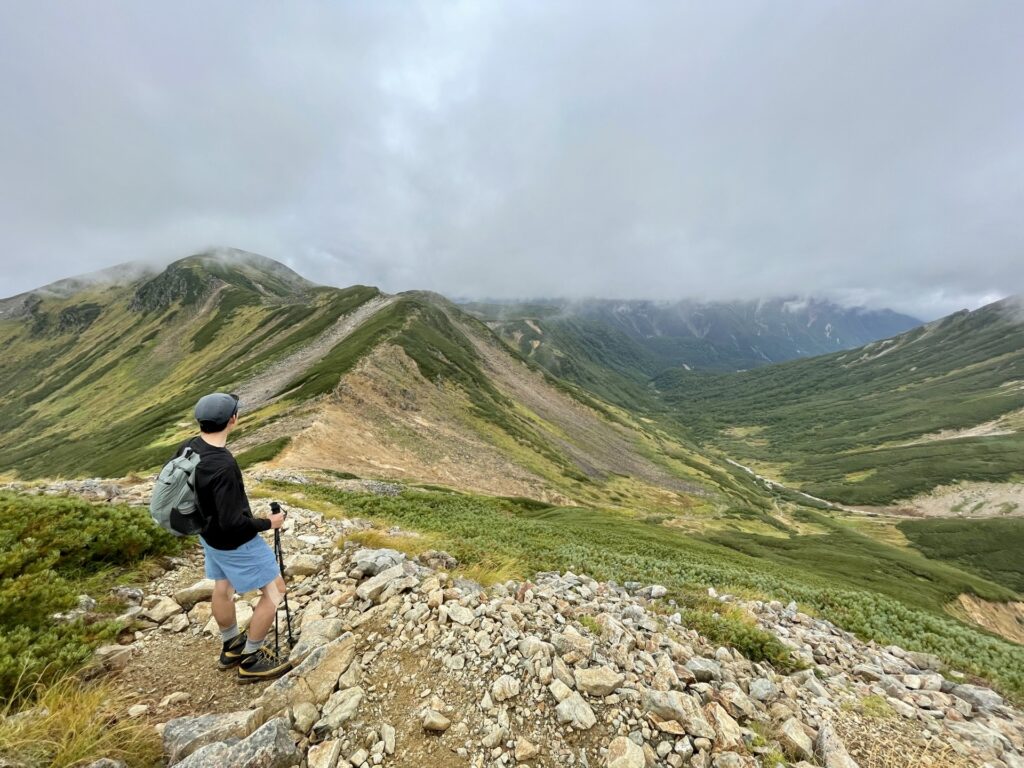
[656,305,1024,504]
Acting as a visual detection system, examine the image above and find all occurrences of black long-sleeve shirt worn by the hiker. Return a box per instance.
[175,435,270,549]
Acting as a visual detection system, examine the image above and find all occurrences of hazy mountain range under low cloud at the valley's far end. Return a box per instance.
[462,299,921,407]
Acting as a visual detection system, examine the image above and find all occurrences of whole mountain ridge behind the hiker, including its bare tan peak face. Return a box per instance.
[0,252,770,524]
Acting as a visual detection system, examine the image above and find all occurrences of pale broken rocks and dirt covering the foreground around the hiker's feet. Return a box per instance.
[66,495,1024,768]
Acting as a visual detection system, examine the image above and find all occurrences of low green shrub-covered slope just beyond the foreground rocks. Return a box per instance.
[267,482,1024,698]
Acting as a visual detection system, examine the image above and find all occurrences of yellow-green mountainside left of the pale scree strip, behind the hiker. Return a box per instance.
[0,257,378,477]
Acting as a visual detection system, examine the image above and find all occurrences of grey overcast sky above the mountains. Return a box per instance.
[0,0,1024,318]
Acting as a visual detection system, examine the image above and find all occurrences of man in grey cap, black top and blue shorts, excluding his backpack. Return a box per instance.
[178,392,290,682]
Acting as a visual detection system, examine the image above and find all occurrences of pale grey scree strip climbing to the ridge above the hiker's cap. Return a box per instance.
[234,295,396,412]
